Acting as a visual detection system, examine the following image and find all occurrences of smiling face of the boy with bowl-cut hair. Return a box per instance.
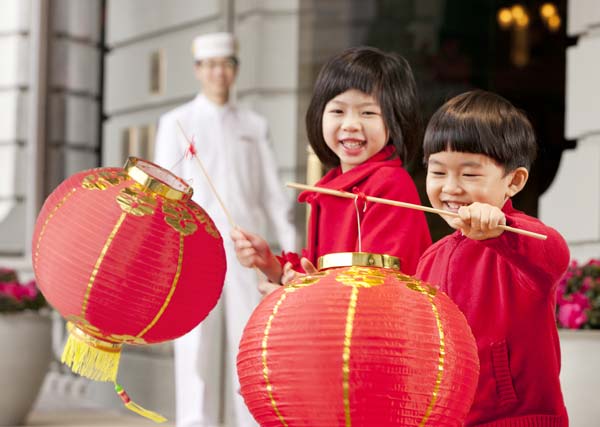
[427,151,528,231]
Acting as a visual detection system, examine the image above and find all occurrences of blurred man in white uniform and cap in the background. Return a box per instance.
[155,33,295,427]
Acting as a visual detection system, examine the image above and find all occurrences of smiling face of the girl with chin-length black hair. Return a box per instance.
[323,89,389,172]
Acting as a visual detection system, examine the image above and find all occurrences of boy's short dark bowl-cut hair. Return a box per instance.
[423,90,537,172]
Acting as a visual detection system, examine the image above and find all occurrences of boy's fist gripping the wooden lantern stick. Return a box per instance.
[452,202,506,240]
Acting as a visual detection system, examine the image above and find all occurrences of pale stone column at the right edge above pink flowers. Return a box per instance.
[540,0,600,262]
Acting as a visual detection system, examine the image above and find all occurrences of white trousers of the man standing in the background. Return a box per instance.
[175,252,260,427]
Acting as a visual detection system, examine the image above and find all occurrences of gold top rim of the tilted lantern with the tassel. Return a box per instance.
[123,157,194,200]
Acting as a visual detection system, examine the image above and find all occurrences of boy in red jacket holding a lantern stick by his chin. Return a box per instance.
[416,91,569,427]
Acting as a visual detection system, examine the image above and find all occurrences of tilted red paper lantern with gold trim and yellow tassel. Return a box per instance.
[32,158,226,422]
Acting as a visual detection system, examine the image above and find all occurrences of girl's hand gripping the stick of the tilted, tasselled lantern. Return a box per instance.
[230,227,281,283]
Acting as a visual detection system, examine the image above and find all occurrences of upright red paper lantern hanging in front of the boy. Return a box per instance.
[237,253,479,427]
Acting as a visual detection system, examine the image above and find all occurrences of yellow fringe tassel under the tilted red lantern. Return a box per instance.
[61,322,122,382]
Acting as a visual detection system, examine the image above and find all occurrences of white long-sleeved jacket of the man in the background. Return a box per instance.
[154,95,295,250]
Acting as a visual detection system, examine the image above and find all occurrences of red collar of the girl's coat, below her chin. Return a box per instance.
[298,144,402,202]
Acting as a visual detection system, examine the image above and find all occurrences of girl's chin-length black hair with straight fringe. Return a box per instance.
[306,47,421,167]
